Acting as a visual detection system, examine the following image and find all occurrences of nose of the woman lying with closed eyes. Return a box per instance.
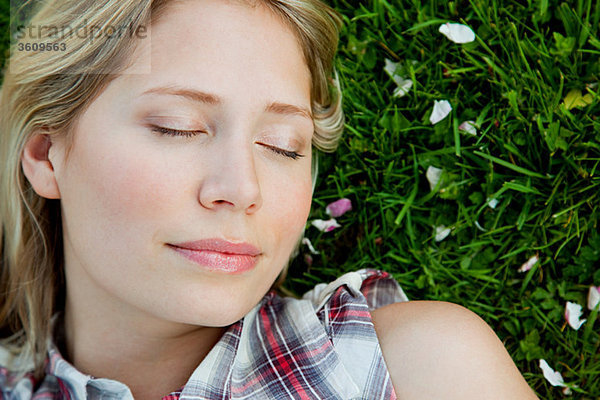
[198,140,262,214]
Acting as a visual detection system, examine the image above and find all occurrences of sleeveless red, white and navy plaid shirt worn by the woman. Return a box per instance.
[0,269,408,400]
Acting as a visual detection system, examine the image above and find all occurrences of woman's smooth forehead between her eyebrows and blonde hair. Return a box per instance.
[118,0,311,101]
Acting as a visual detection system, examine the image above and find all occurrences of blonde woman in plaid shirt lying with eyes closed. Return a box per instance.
[0,0,535,399]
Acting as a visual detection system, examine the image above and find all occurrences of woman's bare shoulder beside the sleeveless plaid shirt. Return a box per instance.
[371,301,537,399]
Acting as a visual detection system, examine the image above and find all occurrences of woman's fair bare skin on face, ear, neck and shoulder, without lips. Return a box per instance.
[22,0,535,399]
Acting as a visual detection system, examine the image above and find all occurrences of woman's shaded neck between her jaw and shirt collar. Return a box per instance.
[64,297,226,399]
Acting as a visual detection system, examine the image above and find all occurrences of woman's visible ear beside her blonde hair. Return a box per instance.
[21,133,60,199]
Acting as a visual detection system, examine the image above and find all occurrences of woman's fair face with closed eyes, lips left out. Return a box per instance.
[50,0,313,326]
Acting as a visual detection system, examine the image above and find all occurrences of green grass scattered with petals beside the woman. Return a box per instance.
[288,0,600,399]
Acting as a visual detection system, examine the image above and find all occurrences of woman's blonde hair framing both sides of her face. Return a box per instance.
[0,0,344,375]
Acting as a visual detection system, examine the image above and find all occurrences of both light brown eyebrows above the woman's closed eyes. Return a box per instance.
[143,86,313,122]
